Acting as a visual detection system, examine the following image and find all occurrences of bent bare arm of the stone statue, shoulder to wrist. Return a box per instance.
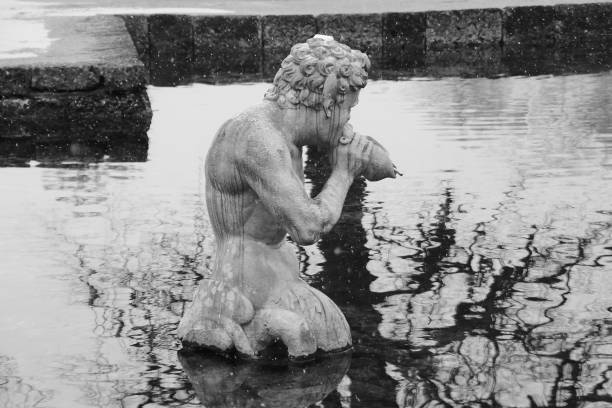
[237,137,354,245]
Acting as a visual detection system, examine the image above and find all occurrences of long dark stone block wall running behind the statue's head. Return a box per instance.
[124,3,612,85]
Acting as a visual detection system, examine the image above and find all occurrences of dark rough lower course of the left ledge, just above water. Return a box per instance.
[0,92,152,140]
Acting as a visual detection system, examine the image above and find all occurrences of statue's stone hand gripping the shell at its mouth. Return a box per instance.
[332,128,374,178]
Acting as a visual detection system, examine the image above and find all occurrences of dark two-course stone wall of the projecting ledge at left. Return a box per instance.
[0,66,151,141]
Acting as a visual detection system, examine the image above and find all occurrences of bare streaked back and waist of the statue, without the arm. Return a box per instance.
[206,116,304,303]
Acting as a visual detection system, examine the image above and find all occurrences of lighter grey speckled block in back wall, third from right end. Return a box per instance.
[425,9,502,51]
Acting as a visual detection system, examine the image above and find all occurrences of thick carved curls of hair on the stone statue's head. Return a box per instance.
[264,34,370,116]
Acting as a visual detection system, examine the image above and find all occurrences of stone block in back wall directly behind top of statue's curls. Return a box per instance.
[316,14,382,69]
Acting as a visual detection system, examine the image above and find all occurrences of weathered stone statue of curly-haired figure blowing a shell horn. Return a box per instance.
[178,35,396,358]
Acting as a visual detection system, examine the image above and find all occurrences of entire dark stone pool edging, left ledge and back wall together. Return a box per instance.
[0,2,612,142]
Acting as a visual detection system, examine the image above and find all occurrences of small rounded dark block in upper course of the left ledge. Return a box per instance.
[31,65,102,92]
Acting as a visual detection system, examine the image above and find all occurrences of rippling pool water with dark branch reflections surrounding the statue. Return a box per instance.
[0,73,612,408]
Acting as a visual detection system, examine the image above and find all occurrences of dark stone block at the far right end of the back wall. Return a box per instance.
[554,3,612,46]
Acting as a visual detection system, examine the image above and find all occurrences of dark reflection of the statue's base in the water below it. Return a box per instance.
[179,352,351,408]
